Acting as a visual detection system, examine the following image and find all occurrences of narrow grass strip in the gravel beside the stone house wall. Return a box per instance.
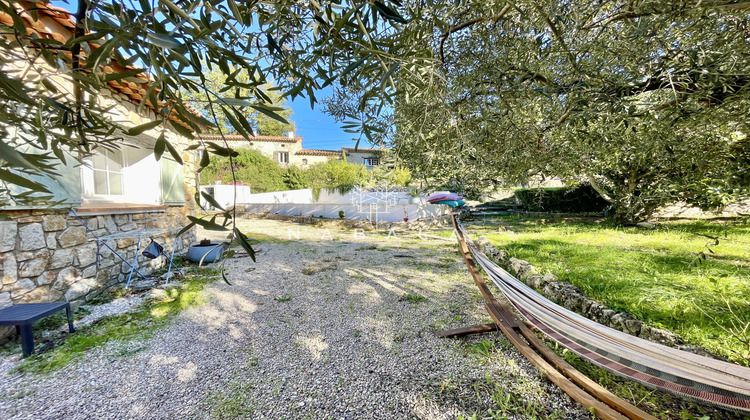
[16,269,219,373]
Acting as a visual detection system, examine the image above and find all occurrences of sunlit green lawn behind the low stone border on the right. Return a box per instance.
[469,217,750,365]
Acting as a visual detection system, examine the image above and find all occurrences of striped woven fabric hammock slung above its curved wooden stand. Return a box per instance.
[456,220,750,414]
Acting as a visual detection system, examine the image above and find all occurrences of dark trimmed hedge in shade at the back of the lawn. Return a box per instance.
[514,184,610,213]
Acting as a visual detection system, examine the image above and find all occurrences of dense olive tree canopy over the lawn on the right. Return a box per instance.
[394,0,750,221]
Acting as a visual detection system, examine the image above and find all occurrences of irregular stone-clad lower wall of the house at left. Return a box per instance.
[0,207,195,337]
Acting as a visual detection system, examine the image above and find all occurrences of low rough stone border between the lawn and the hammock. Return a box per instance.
[476,237,716,357]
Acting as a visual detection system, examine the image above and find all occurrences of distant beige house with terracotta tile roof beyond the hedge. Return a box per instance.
[198,134,386,169]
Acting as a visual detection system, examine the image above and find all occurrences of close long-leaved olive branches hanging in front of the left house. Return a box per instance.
[0,0,422,206]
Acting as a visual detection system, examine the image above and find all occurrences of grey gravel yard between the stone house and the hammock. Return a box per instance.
[0,219,588,419]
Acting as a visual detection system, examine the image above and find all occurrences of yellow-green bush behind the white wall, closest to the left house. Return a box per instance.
[201,149,288,193]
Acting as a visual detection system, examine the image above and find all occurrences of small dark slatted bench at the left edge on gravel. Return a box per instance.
[0,302,75,357]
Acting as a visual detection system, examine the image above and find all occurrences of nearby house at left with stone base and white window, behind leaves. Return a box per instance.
[0,2,195,316]
